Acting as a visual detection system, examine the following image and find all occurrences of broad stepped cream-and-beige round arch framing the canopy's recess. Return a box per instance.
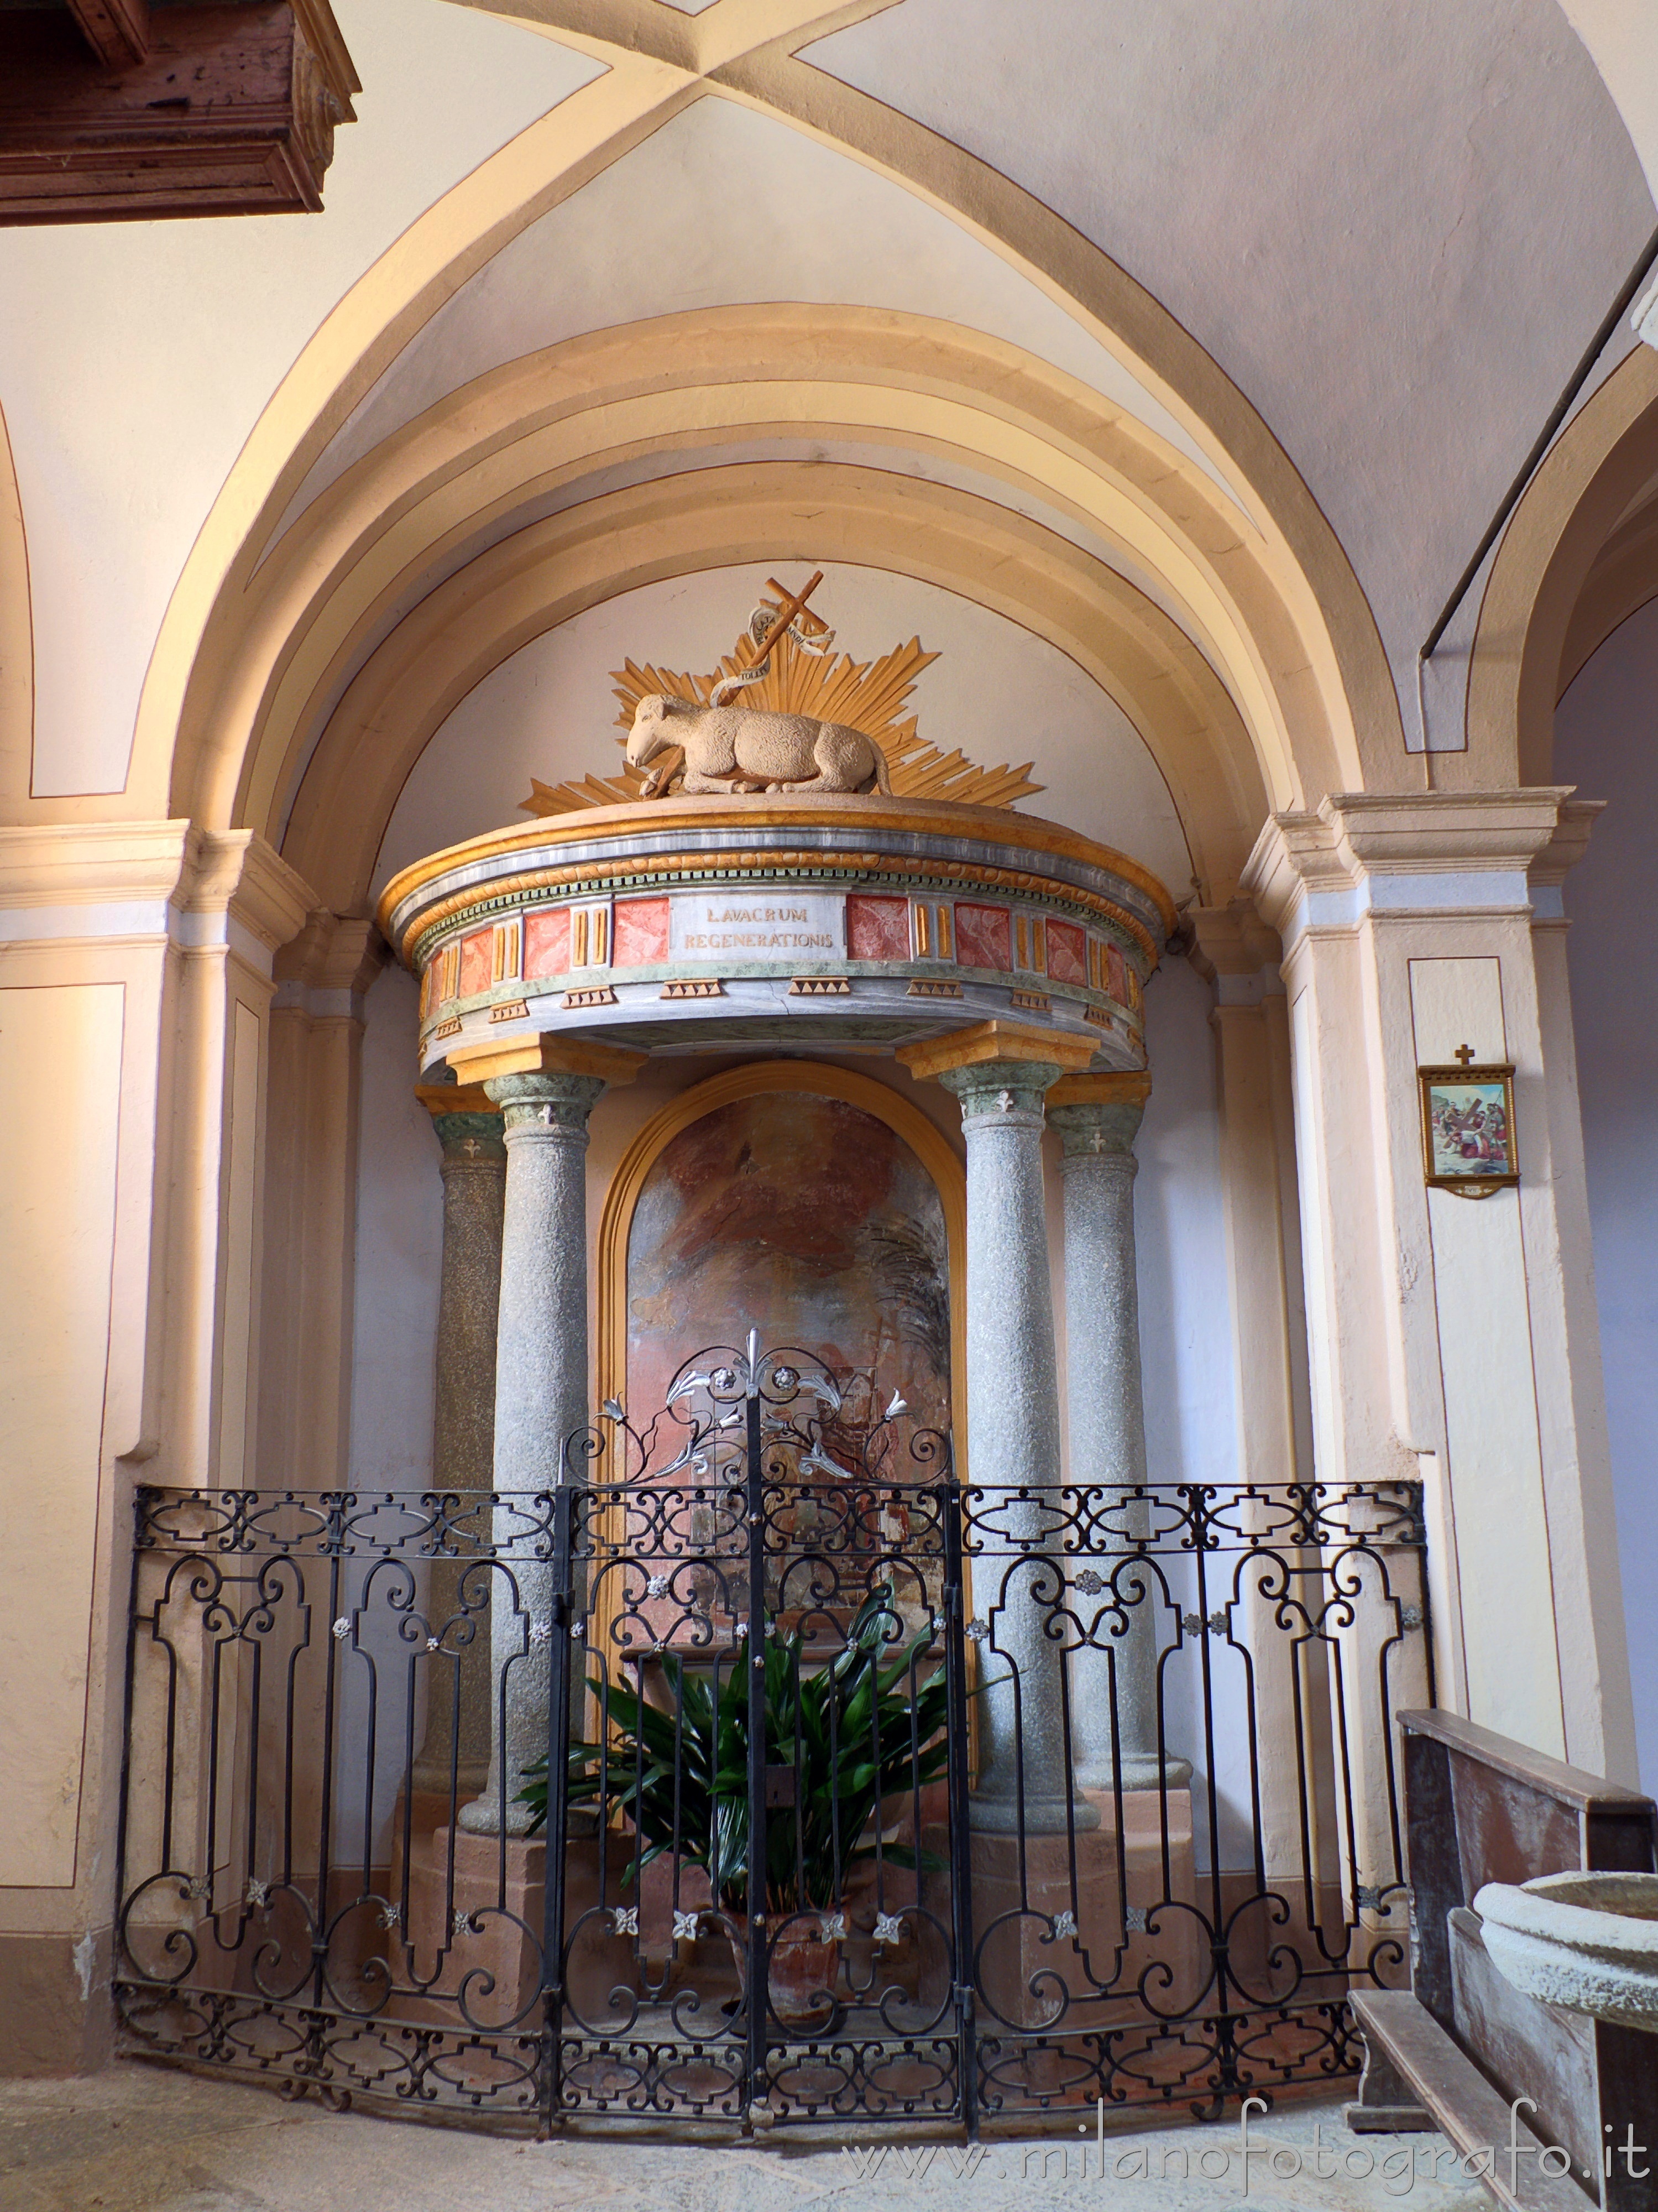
[172,307,1362,905]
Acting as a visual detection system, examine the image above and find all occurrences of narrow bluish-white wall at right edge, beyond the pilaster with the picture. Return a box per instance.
[1554,602,1658,1790]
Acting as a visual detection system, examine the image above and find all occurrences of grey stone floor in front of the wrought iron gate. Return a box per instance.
[0,2066,1490,2212]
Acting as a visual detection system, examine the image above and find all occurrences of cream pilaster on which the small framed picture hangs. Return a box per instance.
[1244,787,1634,1778]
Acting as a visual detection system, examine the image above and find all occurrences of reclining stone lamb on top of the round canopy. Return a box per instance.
[628,692,893,796]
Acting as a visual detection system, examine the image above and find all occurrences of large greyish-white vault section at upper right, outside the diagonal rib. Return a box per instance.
[803,0,1654,717]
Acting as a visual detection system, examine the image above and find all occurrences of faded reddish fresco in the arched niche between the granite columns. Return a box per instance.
[626,1091,950,1646]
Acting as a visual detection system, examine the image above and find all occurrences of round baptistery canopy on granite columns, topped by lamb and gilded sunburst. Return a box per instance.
[380,575,1176,1836]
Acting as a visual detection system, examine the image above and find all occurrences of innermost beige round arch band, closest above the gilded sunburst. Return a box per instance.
[283,462,1267,907]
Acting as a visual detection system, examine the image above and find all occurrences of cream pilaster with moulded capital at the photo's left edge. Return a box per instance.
[0,823,312,2070]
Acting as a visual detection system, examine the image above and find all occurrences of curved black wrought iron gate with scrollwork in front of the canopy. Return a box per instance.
[115,1340,1432,2128]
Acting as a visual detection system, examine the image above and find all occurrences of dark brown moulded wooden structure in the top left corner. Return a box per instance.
[0,0,360,223]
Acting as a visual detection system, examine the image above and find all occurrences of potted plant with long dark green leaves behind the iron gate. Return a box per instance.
[520,1586,948,1913]
